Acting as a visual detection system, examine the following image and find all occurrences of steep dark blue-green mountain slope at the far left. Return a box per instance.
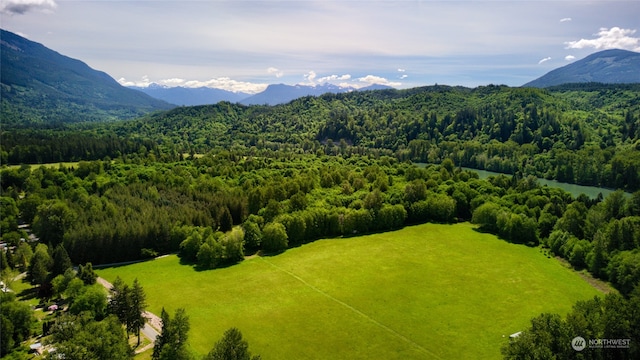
[0,30,172,124]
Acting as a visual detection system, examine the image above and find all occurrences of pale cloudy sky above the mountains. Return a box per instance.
[0,0,640,93]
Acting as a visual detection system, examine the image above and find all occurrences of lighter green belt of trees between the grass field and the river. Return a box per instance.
[1,150,640,294]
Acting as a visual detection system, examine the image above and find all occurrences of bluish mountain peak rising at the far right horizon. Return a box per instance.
[523,49,640,88]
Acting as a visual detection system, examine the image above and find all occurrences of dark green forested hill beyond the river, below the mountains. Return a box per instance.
[1,84,640,191]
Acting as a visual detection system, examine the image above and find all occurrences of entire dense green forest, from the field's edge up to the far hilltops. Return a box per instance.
[0,84,640,358]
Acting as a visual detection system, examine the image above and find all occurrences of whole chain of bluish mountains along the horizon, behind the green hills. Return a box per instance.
[0,26,640,124]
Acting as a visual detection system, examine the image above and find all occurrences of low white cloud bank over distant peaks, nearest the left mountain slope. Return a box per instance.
[118,75,268,94]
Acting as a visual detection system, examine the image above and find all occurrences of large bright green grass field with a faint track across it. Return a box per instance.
[98,223,598,359]
